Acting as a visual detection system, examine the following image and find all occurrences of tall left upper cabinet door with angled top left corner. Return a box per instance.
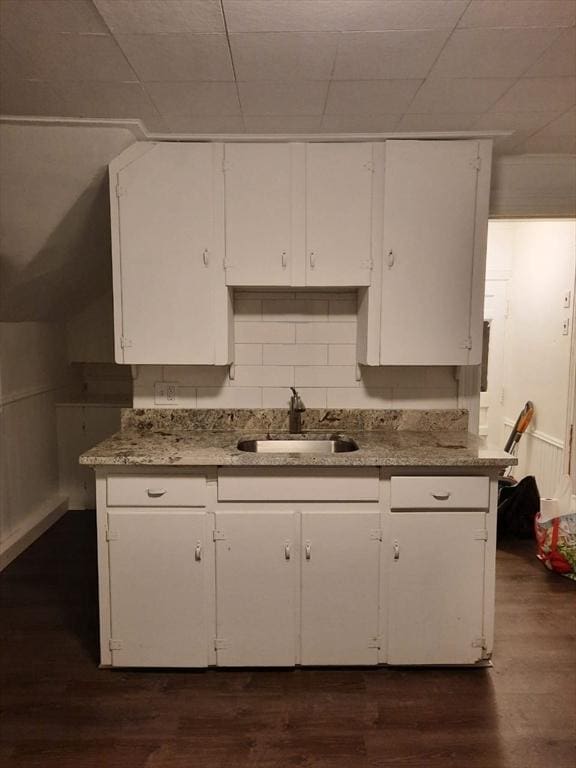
[114,142,219,364]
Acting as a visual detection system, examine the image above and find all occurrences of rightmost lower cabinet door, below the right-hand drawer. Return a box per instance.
[387,511,486,664]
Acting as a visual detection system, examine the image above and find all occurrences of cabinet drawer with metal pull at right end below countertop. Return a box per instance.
[390,475,490,509]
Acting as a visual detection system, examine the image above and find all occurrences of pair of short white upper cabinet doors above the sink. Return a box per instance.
[224,143,374,286]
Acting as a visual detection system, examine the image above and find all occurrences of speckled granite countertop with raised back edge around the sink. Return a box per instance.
[80,409,517,468]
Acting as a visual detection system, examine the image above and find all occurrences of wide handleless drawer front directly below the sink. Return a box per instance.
[218,467,380,501]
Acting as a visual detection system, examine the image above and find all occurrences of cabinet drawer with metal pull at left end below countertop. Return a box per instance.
[106,475,206,507]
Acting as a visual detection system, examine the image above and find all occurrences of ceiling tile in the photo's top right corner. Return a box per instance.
[458,0,576,27]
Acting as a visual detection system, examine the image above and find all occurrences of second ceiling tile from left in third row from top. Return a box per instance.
[53,81,158,118]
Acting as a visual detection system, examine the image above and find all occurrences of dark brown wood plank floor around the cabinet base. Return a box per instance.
[0,512,576,768]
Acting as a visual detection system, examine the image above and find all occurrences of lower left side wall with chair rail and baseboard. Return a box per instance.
[0,323,67,567]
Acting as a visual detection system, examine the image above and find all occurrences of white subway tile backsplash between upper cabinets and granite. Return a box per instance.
[134,289,458,408]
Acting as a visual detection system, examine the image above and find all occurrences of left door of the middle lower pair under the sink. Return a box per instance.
[216,512,298,667]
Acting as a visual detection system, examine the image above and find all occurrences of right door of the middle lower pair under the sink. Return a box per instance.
[301,512,380,664]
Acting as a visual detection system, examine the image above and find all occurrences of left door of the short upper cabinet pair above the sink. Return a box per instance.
[224,144,294,286]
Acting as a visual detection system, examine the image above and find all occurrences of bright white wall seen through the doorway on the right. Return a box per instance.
[488,220,576,495]
